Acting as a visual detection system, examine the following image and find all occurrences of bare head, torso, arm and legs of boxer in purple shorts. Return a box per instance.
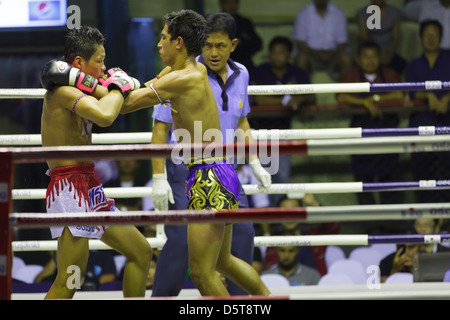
[121,10,270,296]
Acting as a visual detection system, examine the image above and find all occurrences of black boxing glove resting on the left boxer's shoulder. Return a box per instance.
[41,60,98,94]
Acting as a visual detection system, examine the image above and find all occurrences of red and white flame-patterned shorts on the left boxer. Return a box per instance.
[46,164,119,239]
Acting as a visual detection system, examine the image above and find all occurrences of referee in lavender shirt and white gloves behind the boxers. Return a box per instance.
[152,12,271,297]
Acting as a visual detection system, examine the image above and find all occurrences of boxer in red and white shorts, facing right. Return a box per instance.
[41,26,152,299]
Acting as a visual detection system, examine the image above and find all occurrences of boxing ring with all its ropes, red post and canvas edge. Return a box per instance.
[0,81,450,299]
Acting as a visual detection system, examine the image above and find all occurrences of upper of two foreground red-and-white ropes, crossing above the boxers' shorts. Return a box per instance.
[2,135,450,164]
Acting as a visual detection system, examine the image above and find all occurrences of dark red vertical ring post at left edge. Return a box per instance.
[0,148,14,300]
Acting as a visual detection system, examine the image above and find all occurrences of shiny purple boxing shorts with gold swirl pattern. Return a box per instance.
[186,160,241,210]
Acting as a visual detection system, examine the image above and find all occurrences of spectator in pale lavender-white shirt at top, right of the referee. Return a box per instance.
[294,0,352,80]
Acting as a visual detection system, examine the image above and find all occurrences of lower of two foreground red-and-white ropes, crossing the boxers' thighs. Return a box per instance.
[9,202,450,228]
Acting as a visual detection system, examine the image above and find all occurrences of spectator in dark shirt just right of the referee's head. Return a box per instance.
[249,36,315,207]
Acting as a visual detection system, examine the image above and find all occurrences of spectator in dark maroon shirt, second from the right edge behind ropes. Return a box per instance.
[336,41,403,209]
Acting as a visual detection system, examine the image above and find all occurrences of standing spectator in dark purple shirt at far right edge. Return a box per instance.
[405,20,450,202]
